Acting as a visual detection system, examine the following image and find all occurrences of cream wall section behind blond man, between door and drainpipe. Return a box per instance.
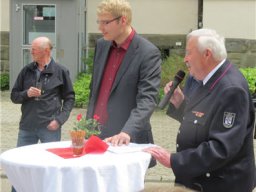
[87,0,198,34]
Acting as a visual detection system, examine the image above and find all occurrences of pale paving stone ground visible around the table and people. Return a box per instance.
[0,91,256,192]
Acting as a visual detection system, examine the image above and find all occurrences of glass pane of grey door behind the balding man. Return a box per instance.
[22,4,56,66]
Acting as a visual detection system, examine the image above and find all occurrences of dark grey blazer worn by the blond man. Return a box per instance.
[87,34,161,143]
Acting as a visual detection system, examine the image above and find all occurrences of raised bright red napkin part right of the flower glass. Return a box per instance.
[84,135,109,153]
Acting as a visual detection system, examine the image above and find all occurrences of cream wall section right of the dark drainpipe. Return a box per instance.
[203,0,256,39]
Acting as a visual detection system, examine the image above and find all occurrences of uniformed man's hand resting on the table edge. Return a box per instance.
[143,147,171,168]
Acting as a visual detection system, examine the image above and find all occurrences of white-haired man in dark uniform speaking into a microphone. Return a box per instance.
[145,29,255,192]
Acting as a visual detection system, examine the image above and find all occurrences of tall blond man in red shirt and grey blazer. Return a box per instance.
[87,0,161,148]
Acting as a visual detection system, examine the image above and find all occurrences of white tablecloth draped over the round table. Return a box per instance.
[0,141,151,192]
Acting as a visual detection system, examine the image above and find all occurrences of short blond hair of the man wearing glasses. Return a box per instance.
[97,0,132,24]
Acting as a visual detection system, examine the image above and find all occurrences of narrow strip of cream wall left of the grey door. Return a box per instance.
[0,0,10,31]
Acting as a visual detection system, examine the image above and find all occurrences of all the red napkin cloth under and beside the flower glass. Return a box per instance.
[46,135,108,159]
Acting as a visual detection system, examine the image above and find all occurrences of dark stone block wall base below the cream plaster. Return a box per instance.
[0,31,256,72]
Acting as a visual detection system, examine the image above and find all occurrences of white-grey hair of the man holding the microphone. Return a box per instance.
[187,29,227,61]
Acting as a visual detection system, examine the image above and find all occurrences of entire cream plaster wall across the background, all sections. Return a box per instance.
[0,0,256,39]
